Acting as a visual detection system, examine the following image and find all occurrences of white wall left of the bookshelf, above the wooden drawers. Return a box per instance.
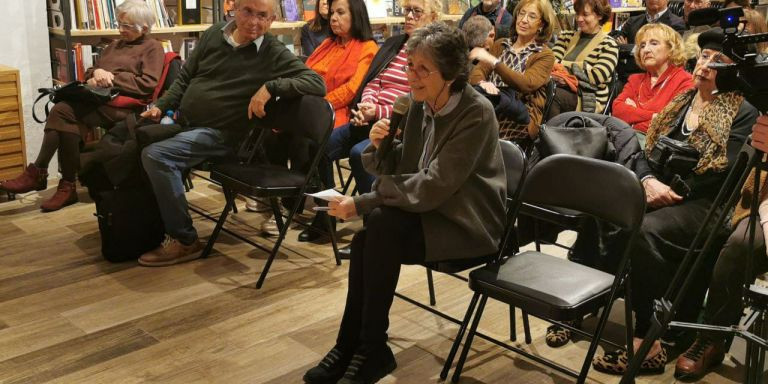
[0,0,58,175]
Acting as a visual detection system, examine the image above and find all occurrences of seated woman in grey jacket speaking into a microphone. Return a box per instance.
[304,23,506,384]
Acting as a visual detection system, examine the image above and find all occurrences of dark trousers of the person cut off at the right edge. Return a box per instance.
[704,218,768,338]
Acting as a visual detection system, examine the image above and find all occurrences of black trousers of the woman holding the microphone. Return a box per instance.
[336,207,425,352]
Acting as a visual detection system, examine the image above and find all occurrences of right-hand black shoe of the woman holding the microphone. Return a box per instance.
[338,344,397,384]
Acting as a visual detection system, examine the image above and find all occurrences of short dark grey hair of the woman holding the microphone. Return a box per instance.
[405,22,469,92]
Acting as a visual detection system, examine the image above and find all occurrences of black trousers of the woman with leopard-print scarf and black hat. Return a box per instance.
[630,198,716,338]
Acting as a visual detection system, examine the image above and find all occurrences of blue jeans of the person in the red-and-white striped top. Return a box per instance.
[320,124,375,194]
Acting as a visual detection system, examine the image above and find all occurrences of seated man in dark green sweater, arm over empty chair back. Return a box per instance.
[139,0,325,266]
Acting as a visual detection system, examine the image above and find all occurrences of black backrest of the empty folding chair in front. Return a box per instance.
[520,155,645,230]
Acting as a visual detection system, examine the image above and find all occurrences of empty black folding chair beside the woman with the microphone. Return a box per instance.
[440,155,645,383]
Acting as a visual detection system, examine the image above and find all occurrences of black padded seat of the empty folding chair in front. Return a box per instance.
[469,251,613,321]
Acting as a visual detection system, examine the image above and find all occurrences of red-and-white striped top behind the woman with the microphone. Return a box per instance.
[352,45,411,121]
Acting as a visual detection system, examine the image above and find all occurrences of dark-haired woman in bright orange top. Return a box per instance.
[307,0,379,128]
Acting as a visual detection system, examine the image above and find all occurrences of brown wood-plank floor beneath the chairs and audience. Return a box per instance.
[0,175,756,384]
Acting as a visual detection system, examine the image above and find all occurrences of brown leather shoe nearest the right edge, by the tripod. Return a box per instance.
[675,337,725,380]
